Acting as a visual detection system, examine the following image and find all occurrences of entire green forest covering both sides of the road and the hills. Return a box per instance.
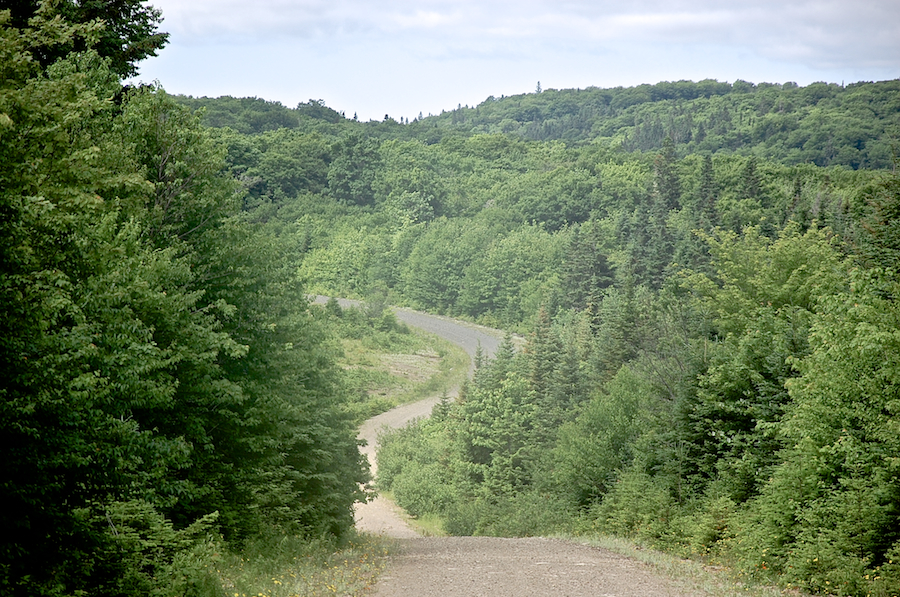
[0,2,900,596]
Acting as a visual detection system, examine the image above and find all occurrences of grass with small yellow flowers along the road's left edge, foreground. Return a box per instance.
[216,535,392,597]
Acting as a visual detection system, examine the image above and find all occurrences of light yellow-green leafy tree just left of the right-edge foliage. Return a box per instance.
[685,226,846,502]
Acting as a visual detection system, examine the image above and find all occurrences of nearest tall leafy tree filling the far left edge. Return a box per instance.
[0,12,229,595]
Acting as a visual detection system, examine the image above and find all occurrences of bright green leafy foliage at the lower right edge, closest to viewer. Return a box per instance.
[745,271,900,594]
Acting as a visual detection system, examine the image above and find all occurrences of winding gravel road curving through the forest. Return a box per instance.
[316,297,705,597]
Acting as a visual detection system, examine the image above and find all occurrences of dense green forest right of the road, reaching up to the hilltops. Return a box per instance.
[178,75,900,595]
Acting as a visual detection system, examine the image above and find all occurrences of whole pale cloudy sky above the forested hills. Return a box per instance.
[138,0,900,120]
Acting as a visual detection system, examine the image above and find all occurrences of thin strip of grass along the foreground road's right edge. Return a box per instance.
[558,535,801,597]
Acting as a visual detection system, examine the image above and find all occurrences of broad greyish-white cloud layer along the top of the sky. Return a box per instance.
[155,0,900,66]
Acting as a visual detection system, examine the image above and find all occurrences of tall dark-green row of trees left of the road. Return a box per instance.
[0,1,368,596]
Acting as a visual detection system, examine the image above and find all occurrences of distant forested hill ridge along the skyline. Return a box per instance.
[179,80,900,169]
